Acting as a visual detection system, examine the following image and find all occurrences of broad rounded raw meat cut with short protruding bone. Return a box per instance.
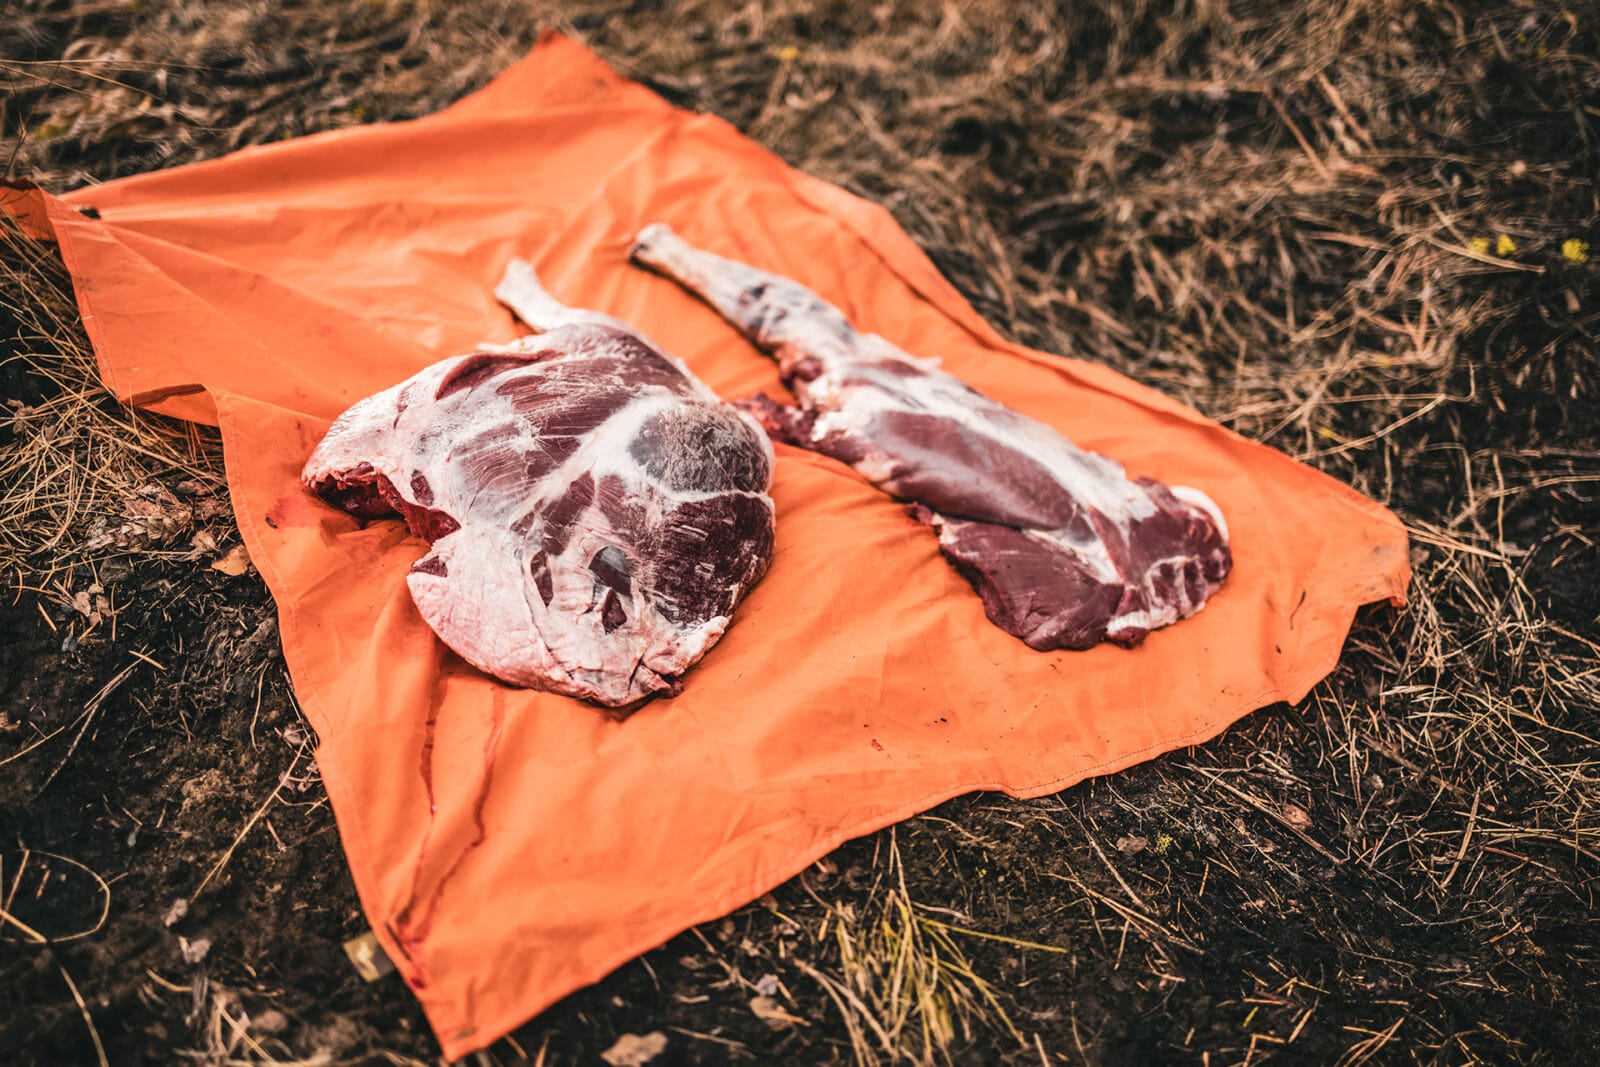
[301,261,773,705]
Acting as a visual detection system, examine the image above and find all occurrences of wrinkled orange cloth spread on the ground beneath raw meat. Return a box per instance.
[0,37,1408,1057]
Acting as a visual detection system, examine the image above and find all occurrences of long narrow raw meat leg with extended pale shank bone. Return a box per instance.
[632,224,1232,649]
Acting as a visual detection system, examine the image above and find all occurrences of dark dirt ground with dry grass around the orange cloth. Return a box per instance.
[0,0,1600,1067]
